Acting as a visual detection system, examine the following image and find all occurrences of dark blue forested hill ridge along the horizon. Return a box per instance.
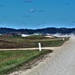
[0,27,75,34]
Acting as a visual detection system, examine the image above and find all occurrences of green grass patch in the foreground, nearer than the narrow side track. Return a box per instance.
[0,50,52,75]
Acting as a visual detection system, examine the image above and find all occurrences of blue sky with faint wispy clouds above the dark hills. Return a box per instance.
[0,0,75,29]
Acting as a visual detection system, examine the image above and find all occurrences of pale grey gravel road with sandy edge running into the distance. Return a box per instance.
[9,37,75,75]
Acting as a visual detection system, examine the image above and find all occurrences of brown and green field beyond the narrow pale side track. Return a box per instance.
[0,36,69,49]
